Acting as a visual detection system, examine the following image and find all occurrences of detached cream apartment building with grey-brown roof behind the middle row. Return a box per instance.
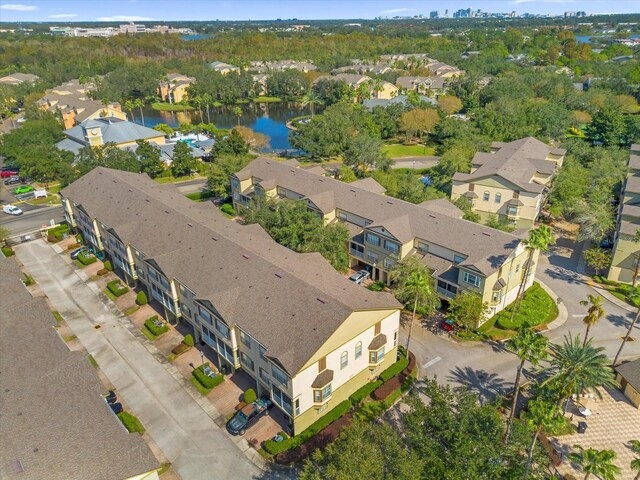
[451,137,566,228]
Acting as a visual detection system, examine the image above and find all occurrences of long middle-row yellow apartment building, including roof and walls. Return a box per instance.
[231,158,537,320]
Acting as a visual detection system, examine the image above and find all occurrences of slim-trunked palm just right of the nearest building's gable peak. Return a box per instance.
[389,257,440,351]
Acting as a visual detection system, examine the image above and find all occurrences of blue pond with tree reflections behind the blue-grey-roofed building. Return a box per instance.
[138,102,322,150]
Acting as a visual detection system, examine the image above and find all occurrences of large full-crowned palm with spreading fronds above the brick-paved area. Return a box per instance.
[543,334,614,410]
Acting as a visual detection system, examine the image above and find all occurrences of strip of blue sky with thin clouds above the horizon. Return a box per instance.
[0,0,640,22]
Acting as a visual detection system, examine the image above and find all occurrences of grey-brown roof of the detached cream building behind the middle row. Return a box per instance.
[453,137,566,193]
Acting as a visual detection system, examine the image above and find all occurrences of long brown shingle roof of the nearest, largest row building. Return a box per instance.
[61,168,400,374]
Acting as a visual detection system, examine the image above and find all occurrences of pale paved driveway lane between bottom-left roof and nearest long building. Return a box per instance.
[16,240,260,480]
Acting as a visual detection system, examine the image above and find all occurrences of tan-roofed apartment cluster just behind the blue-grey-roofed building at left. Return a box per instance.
[36,79,127,128]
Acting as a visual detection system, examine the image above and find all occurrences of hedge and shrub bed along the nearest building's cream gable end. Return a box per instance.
[263,353,416,464]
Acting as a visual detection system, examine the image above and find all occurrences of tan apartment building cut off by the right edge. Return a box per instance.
[608,145,640,283]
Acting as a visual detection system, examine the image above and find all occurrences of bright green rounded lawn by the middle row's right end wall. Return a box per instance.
[487,282,558,333]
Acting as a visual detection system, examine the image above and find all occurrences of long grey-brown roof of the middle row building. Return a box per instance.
[236,158,521,275]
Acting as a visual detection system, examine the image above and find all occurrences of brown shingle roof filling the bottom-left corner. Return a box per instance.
[0,255,159,480]
